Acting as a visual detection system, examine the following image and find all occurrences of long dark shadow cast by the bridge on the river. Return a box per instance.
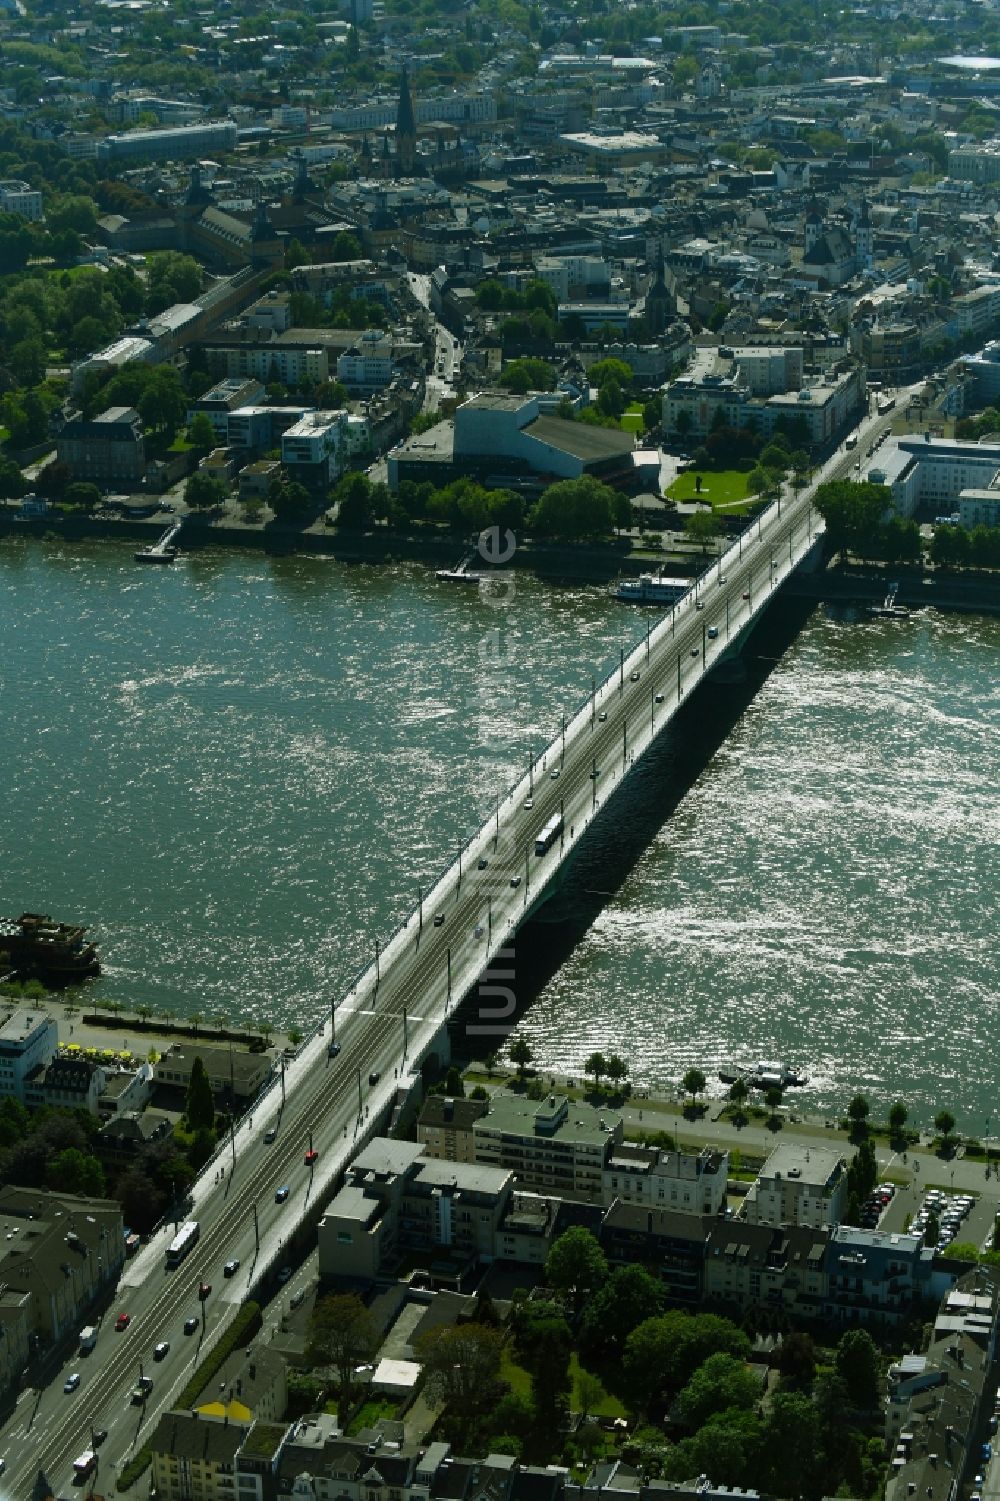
[449,597,815,1061]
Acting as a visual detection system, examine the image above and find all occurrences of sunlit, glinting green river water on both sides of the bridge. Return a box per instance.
[0,540,1000,1130]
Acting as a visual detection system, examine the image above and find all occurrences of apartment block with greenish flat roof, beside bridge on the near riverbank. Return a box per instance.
[473,1091,625,1202]
